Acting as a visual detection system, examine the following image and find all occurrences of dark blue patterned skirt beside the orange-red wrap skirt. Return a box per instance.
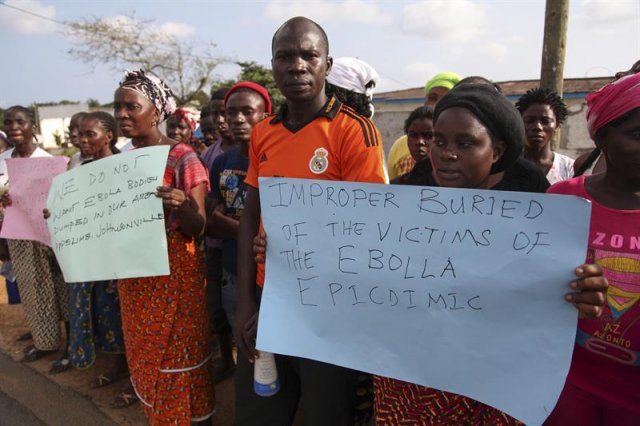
[69,281,124,369]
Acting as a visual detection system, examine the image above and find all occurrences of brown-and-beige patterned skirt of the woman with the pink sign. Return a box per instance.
[8,240,69,351]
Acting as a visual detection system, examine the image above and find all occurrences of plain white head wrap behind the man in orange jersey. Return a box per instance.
[327,58,380,99]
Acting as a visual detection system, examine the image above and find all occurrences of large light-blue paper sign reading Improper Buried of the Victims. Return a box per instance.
[257,178,590,425]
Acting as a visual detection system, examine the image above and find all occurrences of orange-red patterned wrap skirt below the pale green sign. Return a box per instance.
[118,231,215,425]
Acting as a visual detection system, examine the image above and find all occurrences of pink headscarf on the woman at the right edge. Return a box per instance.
[586,73,640,139]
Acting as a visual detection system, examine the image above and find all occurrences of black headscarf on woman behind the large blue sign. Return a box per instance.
[433,84,525,174]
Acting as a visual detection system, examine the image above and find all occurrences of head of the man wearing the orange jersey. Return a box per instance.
[271,21,332,102]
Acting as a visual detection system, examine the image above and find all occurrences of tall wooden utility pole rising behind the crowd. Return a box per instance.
[540,0,569,150]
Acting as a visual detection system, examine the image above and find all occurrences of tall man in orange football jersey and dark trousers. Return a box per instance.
[234,17,386,426]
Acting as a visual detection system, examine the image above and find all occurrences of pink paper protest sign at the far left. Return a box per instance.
[0,157,69,246]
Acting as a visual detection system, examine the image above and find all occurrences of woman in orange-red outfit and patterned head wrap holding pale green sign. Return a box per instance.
[114,70,215,424]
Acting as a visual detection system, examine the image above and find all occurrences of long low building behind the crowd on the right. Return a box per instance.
[373,77,613,158]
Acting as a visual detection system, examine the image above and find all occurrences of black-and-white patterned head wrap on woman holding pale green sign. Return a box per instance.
[120,69,176,122]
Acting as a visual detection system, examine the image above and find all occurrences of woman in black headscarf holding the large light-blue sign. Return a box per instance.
[375,84,607,425]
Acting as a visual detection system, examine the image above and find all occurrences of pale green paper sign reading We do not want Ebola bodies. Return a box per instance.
[47,146,169,282]
